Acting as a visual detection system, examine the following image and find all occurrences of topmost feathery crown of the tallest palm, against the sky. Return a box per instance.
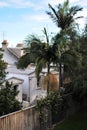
[47,0,82,30]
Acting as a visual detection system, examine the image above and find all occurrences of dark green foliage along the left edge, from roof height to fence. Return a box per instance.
[0,47,21,116]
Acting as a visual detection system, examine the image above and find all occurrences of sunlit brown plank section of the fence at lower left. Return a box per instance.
[0,106,40,130]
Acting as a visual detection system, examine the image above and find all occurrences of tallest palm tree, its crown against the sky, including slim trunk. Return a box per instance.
[47,0,82,87]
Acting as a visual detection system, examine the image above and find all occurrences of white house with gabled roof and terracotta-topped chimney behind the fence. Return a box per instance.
[2,40,58,104]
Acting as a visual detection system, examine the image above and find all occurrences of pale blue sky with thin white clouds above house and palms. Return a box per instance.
[0,0,87,47]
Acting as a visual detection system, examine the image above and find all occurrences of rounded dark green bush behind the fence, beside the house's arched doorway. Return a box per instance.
[0,81,22,116]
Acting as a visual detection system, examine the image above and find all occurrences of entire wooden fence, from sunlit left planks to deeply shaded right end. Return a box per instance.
[0,94,87,130]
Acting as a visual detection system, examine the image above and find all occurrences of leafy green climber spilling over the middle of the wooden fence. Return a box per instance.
[36,92,59,128]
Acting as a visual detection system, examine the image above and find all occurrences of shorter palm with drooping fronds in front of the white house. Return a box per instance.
[18,28,56,94]
